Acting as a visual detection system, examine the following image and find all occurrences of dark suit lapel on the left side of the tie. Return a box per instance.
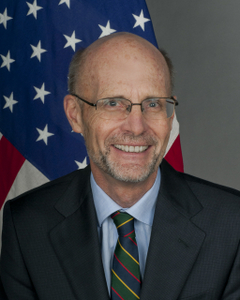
[50,168,109,300]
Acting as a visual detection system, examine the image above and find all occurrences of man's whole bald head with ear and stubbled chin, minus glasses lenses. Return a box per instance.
[64,33,172,182]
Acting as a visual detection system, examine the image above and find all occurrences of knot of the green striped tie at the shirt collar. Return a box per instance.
[111,211,135,237]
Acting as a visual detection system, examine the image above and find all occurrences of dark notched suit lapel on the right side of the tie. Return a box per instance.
[141,161,205,300]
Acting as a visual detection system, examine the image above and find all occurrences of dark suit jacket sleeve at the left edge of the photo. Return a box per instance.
[0,201,38,300]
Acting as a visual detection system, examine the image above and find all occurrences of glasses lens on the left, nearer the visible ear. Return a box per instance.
[97,98,131,120]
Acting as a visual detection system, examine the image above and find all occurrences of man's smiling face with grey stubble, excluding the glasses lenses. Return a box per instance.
[76,40,172,182]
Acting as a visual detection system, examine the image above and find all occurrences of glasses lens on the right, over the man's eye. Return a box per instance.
[142,98,175,120]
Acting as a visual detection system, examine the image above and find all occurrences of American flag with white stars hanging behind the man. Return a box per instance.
[0,0,183,232]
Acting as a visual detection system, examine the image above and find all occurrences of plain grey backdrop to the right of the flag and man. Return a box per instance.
[146,0,240,189]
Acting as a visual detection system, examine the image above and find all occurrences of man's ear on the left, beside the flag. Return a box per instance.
[63,95,83,133]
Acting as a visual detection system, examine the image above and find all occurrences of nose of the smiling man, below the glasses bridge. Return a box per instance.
[122,105,147,136]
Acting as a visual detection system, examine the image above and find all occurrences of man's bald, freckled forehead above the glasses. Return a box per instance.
[77,37,170,96]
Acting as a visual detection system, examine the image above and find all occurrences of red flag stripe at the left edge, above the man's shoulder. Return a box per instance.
[0,136,25,209]
